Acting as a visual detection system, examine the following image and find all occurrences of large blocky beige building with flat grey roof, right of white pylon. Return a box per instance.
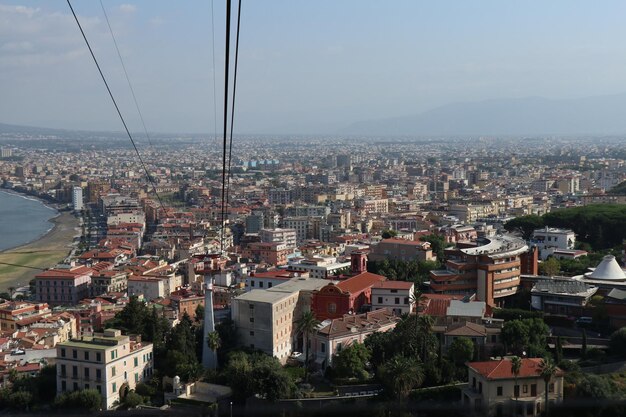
[232,277,328,363]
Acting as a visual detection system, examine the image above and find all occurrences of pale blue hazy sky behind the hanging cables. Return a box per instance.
[0,0,626,133]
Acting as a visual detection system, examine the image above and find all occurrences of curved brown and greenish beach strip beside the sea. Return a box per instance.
[0,212,80,292]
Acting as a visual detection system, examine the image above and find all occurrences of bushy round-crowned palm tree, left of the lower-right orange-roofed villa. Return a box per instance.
[378,356,424,399]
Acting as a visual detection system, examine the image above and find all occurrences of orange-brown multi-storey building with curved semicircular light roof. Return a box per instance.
[430,235,528,306]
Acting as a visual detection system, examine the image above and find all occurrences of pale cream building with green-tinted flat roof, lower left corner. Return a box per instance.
[56,329,153,409]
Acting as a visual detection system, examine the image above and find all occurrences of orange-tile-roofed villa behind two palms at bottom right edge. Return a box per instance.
[461,358,564,416]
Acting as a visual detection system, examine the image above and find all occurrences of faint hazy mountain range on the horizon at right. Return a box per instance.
[340,94,626,136]
